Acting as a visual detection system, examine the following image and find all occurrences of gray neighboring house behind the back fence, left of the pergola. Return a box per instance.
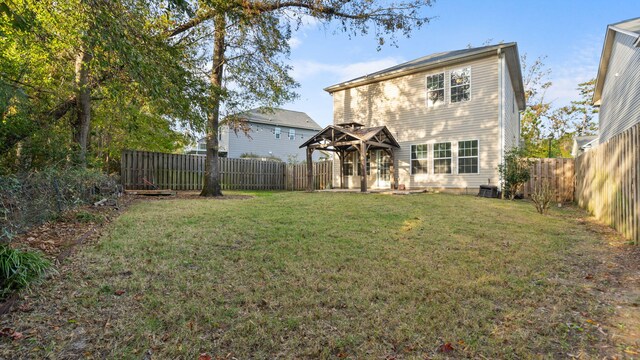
[187,109,322,162]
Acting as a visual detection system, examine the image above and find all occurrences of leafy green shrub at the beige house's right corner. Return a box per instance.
[498,148,531,200]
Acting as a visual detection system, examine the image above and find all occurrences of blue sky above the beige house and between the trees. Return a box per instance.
[283,0,640,127]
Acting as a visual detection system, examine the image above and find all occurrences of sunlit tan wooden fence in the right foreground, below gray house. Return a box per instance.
[576,124,640,245]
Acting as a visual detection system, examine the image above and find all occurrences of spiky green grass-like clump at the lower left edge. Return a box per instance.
[0,244,51,299]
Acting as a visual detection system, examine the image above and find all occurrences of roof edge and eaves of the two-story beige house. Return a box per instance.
[324,42,526,110]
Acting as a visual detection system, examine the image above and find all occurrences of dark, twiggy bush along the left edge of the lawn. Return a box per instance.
[0,168,119,242]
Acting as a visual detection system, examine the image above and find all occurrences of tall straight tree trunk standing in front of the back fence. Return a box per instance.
[200,15,226,196]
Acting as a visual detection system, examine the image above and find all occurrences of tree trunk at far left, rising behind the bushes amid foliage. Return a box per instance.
[73,49,92,167]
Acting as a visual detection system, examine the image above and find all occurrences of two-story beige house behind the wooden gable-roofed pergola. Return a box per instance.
[325,43,525,189]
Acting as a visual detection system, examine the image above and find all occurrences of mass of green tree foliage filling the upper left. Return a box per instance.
[0,0,206,172]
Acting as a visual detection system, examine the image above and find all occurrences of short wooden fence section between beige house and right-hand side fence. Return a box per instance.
[524,158,575,202]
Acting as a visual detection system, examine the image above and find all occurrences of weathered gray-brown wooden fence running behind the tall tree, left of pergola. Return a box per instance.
[120,150,333,190]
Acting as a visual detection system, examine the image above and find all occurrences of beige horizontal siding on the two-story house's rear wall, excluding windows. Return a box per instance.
[333,55,504,188]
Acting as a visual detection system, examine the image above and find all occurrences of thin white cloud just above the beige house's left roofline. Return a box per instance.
[291,57,402,81]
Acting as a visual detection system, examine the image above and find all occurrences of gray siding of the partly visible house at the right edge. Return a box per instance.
[599,32,640,143]
